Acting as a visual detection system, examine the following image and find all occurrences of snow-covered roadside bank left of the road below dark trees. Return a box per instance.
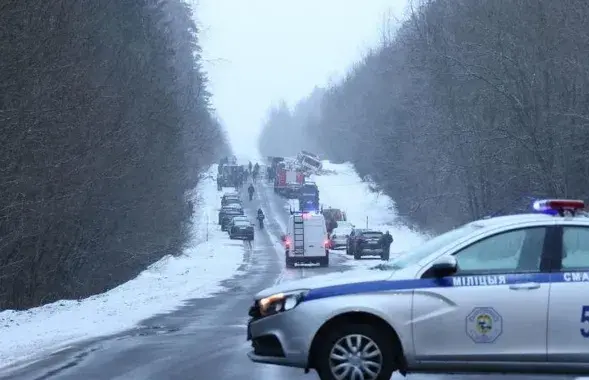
[0,165,244,367]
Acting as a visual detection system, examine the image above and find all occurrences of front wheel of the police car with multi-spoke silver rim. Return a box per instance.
[316,324,395,380]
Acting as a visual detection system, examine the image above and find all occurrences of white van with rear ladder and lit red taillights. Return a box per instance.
[283,212,329,268]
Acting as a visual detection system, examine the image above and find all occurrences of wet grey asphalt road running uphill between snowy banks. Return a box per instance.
[0,180,572,380]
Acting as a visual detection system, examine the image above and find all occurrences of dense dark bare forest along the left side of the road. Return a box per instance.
[0,0,229,310]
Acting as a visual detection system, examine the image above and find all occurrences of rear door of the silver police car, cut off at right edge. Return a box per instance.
[548,222,589,367]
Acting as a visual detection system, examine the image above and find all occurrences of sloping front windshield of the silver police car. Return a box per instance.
[391,223,482,269]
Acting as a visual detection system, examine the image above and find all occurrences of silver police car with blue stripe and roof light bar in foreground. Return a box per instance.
[248,200,589,380]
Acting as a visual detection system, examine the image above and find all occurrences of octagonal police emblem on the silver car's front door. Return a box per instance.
[466,307,503,343]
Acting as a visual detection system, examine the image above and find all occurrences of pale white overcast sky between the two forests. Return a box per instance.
[195,0,407,157]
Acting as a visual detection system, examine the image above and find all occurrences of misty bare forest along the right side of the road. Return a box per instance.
[260,0,589,232]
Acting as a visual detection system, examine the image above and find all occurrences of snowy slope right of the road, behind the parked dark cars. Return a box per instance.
[309,161,427,267]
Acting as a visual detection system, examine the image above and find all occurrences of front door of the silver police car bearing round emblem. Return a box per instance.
[413,227,554,365]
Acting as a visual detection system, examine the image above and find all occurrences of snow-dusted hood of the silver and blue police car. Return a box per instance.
[255,270,414,299]
